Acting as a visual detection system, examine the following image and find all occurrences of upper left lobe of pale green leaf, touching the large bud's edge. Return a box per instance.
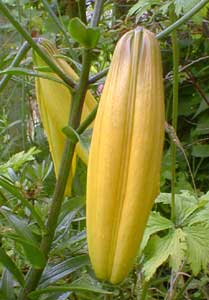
[140,211,174,252]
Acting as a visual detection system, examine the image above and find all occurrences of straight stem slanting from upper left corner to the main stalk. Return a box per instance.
[0,1,75,88]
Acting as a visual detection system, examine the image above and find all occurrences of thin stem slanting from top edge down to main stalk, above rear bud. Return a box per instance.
[42,0,78,60]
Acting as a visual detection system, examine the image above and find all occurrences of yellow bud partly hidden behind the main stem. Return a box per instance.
[33,40,97,195]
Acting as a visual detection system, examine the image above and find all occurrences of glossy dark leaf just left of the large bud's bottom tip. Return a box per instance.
[39,255,89,288]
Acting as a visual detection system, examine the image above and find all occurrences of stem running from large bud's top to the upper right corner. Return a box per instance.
[156,0,209,39]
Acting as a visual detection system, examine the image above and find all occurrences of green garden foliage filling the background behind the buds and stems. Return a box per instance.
[0,0,209,300]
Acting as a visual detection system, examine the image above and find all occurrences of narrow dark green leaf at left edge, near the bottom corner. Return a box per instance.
[0,247,25,286]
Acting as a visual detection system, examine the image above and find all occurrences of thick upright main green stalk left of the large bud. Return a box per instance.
[20,49,91,300]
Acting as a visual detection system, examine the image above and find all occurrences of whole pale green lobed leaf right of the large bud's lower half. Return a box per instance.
[142,191,209,280]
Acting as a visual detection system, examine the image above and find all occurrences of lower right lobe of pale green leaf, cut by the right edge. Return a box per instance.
[184,224,209,275]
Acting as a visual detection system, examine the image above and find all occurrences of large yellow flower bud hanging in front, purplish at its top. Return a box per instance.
[87,28,165,283]
